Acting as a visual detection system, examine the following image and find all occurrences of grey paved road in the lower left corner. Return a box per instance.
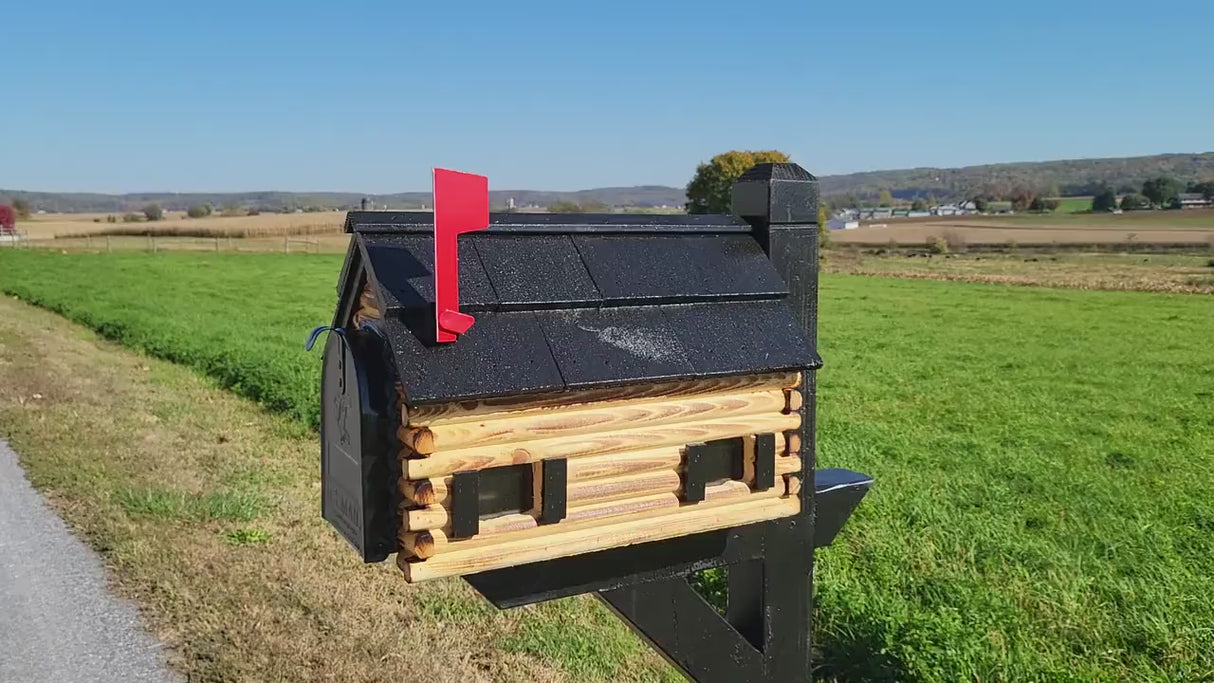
[0,442,181,683]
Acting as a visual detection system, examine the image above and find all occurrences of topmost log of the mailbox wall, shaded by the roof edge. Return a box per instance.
[404,372,801,427]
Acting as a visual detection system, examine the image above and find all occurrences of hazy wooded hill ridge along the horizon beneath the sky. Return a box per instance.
[9,152,1214,212]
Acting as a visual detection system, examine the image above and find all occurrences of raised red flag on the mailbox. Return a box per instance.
[435,169,489,342]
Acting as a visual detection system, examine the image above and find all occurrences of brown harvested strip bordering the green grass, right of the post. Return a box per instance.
[823,247,1214,294]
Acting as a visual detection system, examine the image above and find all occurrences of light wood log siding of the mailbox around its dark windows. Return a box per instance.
[352,277,804,582]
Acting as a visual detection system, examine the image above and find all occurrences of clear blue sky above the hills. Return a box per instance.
[7,0,1214,193]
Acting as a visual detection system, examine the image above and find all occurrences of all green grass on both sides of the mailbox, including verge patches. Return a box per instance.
[0,251,1214,682]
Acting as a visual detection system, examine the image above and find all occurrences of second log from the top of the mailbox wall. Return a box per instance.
[412,388,787,454]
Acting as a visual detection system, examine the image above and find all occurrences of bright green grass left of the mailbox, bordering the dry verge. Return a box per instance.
[0,250,341,426]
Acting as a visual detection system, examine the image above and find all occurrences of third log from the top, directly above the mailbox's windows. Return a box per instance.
[402,412,801,479]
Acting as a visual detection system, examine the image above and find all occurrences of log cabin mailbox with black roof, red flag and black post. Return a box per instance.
[312,164,872,682]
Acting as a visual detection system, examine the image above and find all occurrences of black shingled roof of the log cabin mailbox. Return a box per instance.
[335,211,821,405]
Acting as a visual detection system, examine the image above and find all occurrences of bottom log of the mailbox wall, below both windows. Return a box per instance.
[397,488,800,582]
